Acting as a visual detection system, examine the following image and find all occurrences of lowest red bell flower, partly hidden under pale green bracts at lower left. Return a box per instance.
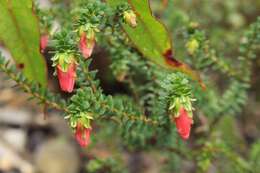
[75,123,92,147]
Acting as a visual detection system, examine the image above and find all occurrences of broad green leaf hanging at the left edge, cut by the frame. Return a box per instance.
[0,0,47,86]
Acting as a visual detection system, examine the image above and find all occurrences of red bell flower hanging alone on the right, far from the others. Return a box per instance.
[174,107,193,140]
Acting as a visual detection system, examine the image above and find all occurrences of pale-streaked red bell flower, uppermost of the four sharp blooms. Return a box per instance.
[79,32,95,59]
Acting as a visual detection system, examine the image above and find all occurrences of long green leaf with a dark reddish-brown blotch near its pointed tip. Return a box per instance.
[107,0,203,86]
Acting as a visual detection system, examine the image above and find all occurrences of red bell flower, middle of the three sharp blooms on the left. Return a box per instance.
[57,63,76,93]
